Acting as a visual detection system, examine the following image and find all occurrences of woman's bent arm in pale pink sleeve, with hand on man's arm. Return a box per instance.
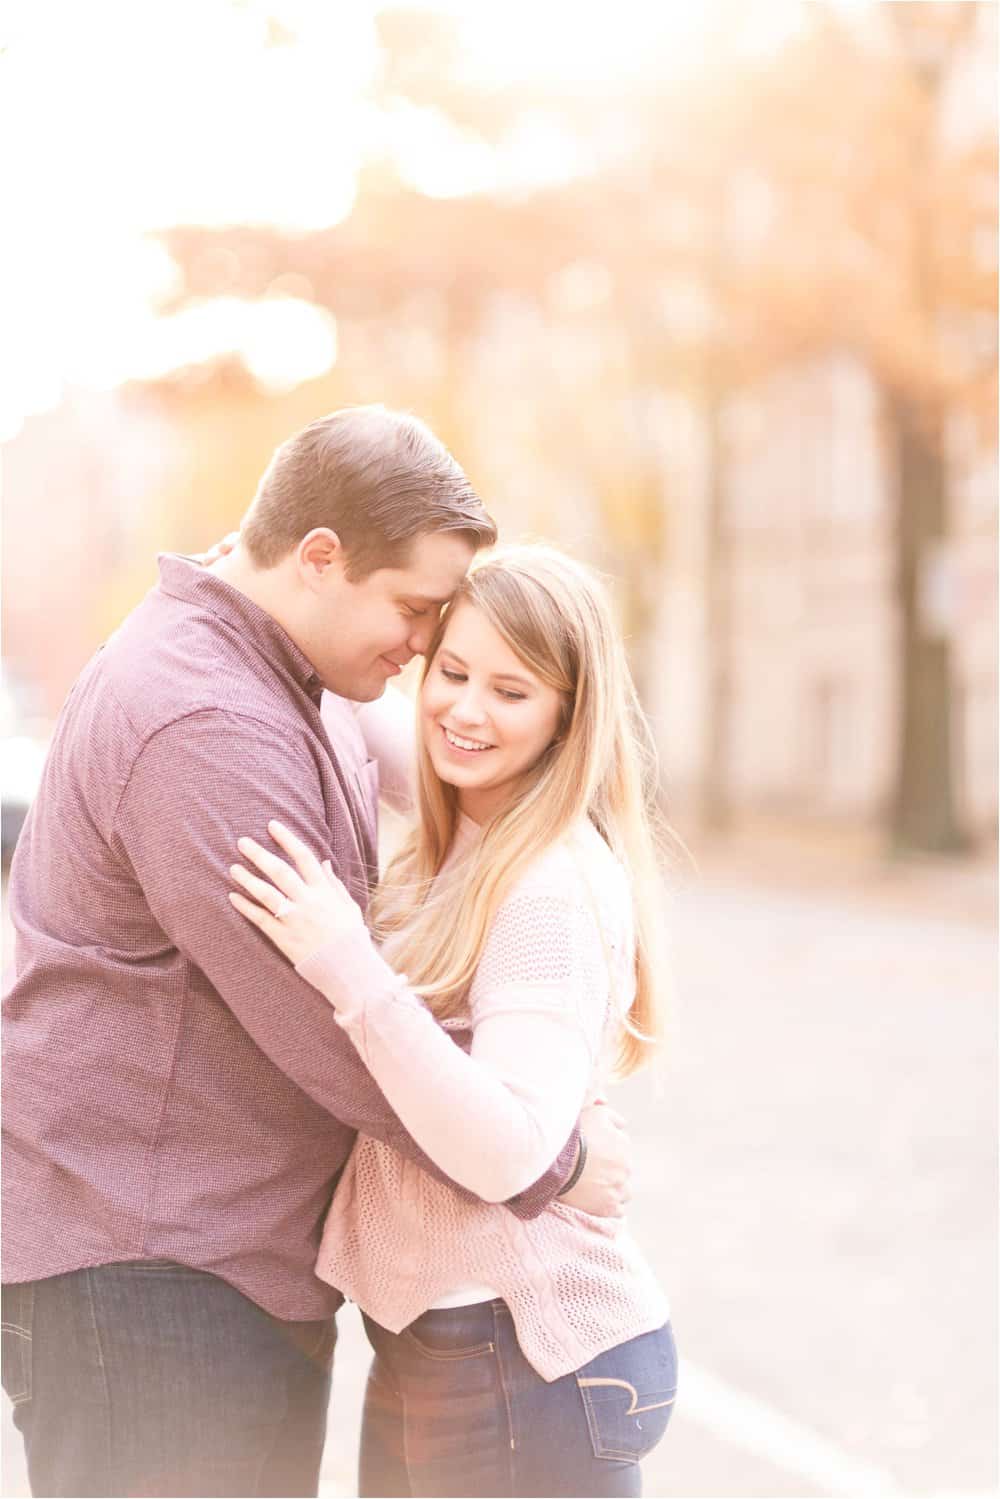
[231,824,607,1202]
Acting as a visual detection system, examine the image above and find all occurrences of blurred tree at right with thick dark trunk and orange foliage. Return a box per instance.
[740,0,997,851]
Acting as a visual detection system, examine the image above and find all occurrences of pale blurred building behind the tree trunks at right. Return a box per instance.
[655,355,997,836]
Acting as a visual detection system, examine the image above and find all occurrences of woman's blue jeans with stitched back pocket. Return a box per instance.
[358,1301,678,1499]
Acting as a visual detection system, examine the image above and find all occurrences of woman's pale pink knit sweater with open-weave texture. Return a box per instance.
[298,818,669,1381]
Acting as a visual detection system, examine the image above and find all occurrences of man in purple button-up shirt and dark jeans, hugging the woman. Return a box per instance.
[3,408,622,1495]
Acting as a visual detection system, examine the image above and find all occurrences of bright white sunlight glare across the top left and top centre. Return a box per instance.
[0,0,815,436]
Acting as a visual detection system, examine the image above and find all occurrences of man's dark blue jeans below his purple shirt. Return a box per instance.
[3,1261,336,1499]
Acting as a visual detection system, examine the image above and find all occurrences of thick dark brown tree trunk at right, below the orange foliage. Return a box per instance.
[891,396,967,854]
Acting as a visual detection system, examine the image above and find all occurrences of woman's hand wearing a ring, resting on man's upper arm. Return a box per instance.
[229,821,367,967]
